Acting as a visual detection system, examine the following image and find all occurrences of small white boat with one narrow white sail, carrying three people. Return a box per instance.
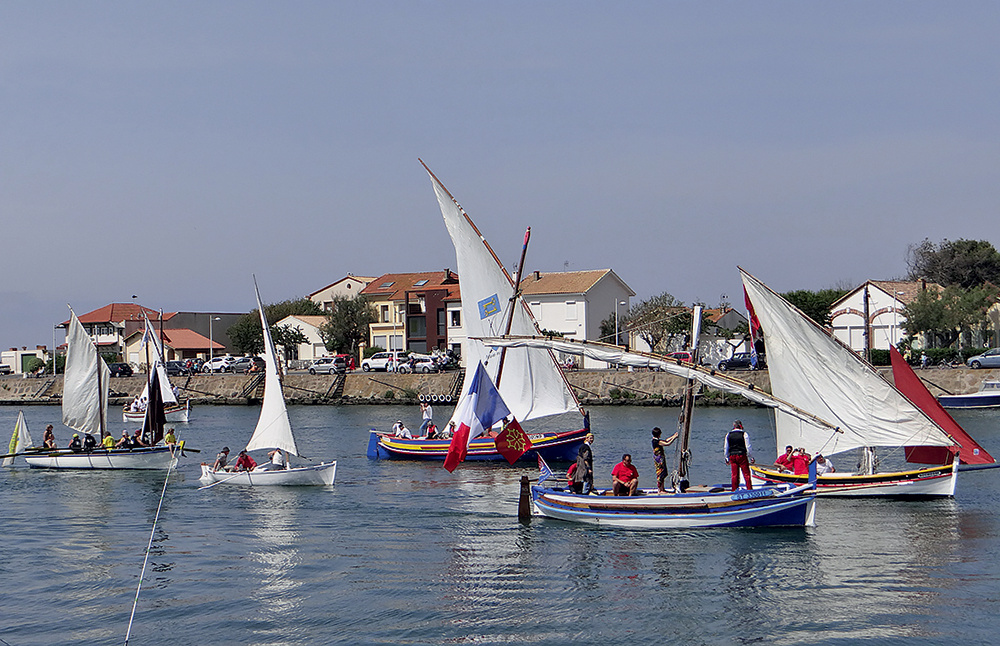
[201,278,337,486]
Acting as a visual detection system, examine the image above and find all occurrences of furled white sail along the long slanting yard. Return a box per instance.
[480,336,839,435]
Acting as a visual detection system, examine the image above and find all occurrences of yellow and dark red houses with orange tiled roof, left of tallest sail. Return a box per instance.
[360,269,465,353]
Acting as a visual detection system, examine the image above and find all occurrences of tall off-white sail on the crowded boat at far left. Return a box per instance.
[62,309,111,438]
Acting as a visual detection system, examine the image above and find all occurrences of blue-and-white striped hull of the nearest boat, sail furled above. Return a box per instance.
[531,486,816,529]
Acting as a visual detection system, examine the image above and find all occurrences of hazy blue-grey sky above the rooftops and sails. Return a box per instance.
[0,0,1000,349]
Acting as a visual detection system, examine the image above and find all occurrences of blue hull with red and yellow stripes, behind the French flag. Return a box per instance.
[368,428,590,462]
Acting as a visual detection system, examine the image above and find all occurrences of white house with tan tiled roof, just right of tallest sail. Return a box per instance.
[521,269,635,368]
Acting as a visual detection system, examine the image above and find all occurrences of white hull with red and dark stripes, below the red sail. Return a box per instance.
[750,464,958,499]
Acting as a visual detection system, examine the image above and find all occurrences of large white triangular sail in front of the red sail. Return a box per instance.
[740,269,955,455]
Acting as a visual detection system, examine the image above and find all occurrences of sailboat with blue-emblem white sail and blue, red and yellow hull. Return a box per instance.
[368,161,589,461]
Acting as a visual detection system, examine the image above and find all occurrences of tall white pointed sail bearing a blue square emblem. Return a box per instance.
[425,167,578,421]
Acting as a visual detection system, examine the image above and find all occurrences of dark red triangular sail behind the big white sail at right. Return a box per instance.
[889,347,996,464]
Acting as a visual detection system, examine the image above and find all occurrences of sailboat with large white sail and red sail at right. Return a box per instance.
[740,269,993,498]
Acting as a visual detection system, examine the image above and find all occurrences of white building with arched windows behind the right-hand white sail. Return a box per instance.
[830,280,942,352]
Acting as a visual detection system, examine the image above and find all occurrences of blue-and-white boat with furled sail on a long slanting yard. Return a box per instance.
[482,308,823,529]
